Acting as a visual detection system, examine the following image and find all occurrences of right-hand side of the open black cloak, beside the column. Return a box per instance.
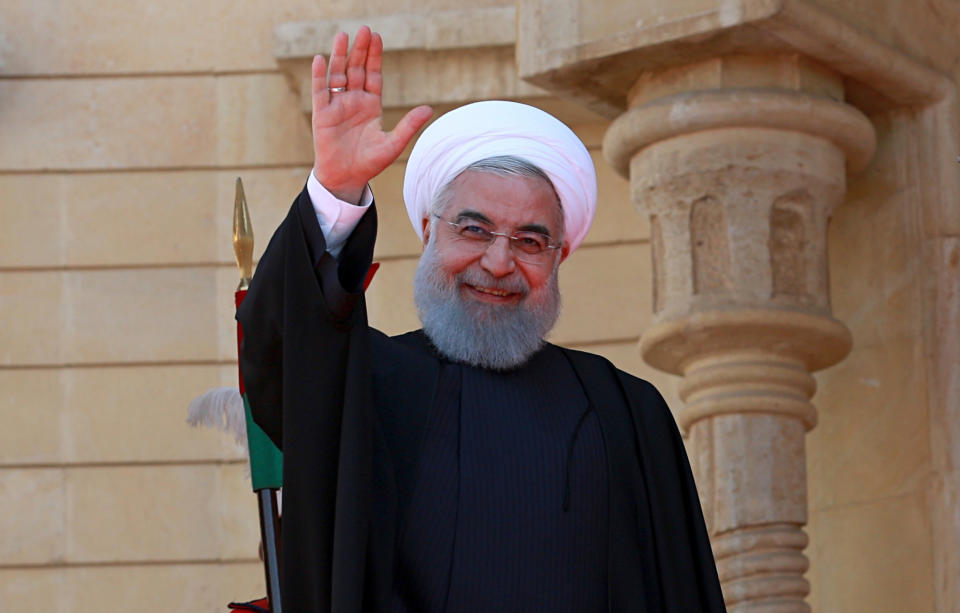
[564,349,726,613]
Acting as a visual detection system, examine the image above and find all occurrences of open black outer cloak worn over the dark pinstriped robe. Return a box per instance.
[237,189,725,613]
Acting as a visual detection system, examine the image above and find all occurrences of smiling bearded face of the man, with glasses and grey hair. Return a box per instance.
[414,155,568,370]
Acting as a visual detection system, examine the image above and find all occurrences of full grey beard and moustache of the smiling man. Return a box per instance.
[413,237,560,370]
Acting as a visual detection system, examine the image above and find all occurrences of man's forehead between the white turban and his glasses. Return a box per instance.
[443,170,562,232]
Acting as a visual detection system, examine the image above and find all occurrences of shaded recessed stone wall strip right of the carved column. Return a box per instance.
[807,111,936,611]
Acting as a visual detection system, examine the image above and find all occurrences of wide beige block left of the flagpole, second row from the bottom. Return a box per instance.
[65,464,259,563]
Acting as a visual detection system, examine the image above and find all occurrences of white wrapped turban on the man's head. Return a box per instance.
[403,100,597,253]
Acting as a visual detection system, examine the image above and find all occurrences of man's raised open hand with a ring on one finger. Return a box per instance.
[313,26,433,203]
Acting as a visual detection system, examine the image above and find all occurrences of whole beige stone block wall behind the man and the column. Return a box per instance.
[0,0,960,613]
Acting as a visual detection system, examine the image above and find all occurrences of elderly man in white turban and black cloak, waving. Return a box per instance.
[238,28,723,613]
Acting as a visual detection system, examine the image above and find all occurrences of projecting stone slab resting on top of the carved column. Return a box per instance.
[517,0,952,119]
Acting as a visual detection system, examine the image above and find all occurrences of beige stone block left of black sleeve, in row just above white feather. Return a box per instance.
[0,267,236,364]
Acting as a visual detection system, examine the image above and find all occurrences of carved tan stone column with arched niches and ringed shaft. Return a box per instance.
[604,54,875,613]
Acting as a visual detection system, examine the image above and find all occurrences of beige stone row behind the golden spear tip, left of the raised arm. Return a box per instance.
[0,170,280,268]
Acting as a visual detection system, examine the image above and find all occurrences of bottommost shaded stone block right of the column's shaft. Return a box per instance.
[808,493,935,613]
